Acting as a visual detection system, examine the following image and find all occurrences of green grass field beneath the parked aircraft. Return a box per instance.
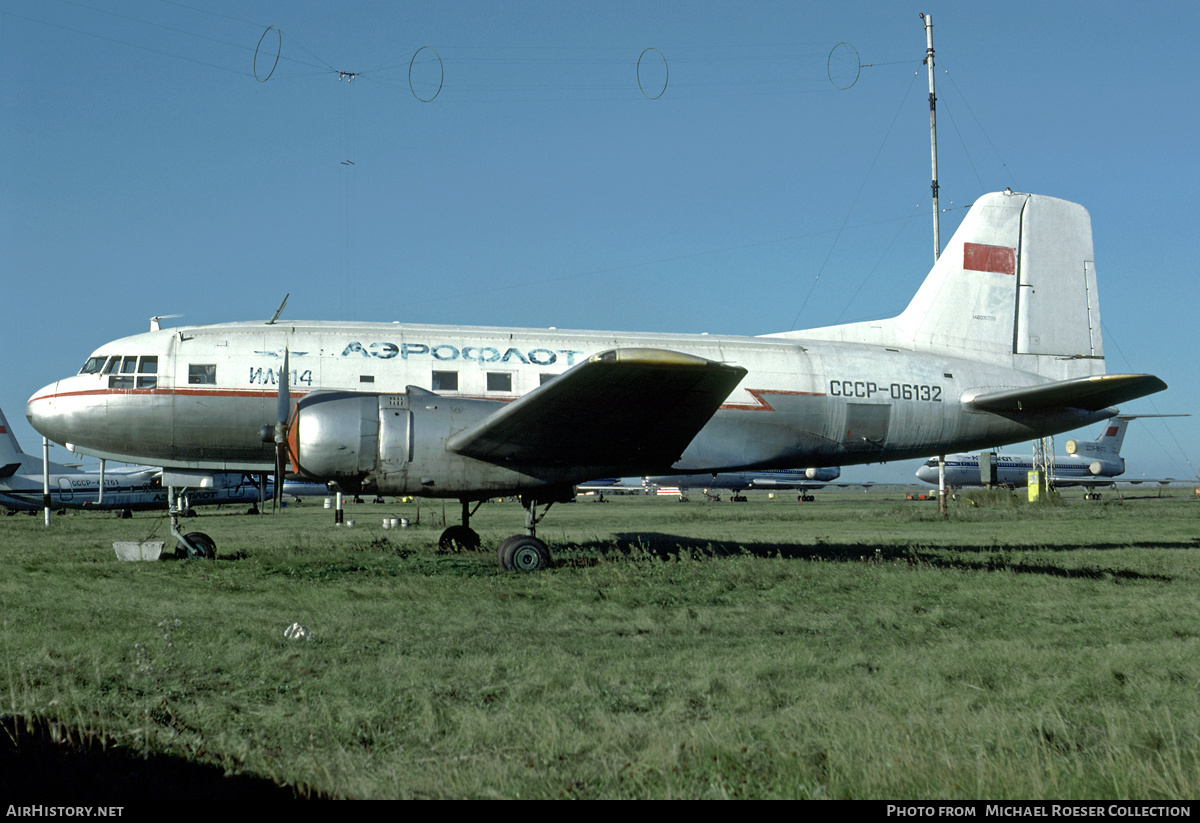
[0,488,1200,803]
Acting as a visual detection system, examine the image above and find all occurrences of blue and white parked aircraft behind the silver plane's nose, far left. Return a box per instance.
[0,410,328,513]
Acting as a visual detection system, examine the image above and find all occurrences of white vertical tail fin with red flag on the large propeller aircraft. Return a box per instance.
[775,192,1104,380]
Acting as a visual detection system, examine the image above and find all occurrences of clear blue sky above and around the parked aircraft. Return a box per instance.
[0,0,1200,480]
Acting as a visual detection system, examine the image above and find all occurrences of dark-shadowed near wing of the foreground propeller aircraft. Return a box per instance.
[446,348,746,465]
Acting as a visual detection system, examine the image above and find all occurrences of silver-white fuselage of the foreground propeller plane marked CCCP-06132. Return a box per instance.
[26,323,1114,495]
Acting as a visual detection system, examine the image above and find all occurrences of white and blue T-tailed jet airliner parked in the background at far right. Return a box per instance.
[917,414,1182,499]
